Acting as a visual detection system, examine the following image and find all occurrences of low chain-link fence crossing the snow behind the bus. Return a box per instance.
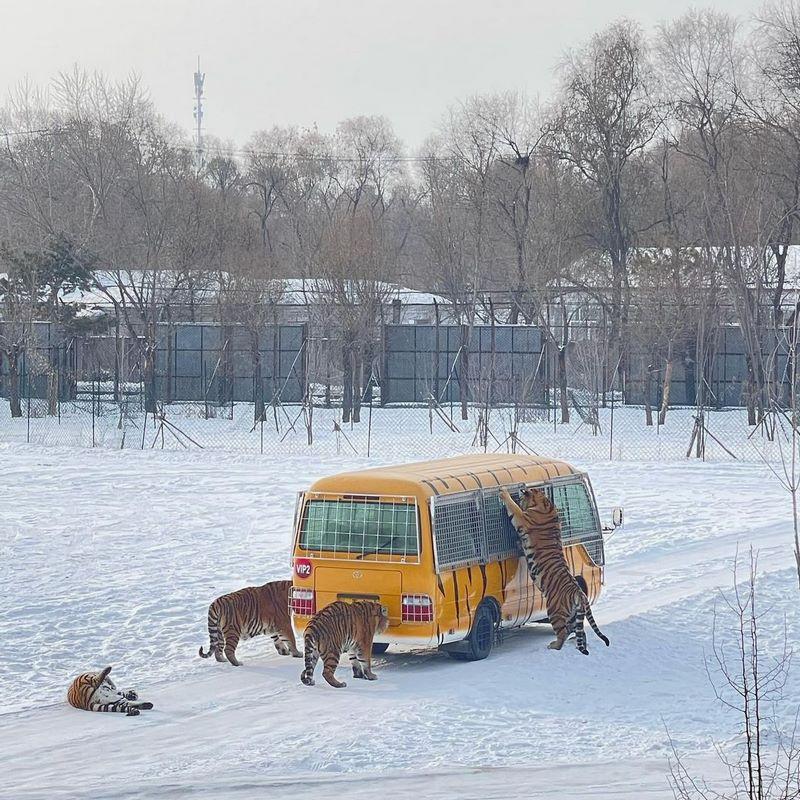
[0,381,789,462]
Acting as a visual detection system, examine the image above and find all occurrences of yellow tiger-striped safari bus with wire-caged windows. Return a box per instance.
[290,454,621,661]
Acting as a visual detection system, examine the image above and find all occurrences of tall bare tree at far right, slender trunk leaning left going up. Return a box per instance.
[658,11,779,424]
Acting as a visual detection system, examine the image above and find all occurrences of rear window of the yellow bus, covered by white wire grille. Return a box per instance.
[299,498,419,557]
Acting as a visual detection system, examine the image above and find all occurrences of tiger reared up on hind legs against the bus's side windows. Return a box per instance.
[500,489,610,655]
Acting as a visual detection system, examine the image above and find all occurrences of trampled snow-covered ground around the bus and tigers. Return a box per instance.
[0,444,800,798]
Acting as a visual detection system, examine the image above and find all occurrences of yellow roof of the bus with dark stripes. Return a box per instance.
[310,453,580,496]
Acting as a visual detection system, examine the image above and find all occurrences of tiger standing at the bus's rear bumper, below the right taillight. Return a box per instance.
[300,600,389,689]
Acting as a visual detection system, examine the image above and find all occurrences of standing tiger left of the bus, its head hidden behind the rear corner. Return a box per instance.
[200,581,301,667]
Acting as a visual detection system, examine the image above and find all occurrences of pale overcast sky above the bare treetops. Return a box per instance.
[0,0,760,149]
